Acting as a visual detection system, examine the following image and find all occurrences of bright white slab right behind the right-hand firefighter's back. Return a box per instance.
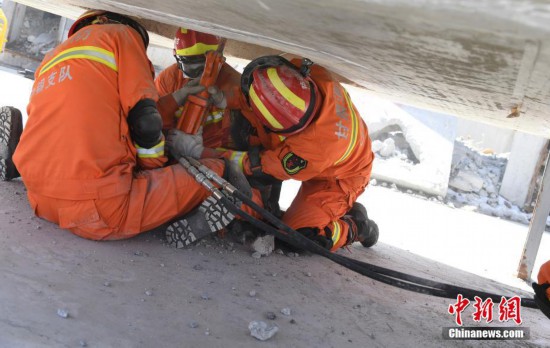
[352,85,456,196]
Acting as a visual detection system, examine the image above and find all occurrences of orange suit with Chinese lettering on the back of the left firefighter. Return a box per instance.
[14,24,223,240]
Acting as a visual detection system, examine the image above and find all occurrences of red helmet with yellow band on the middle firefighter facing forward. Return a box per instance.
[174,28,221,60]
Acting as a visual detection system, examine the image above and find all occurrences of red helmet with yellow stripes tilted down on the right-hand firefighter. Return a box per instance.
[241,56,320,135]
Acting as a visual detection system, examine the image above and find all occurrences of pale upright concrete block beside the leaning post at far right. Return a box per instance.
[500,132,547,207]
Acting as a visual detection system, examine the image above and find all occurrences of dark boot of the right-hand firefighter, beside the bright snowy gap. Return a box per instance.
[342,202,379,248]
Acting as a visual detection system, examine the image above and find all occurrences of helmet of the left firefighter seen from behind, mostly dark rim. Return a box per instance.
[68,10,149,48]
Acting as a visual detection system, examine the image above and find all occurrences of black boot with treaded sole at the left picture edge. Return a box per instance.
[0,106,23,181]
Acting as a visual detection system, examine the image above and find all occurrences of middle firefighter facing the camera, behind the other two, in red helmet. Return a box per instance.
[155,28,241,149]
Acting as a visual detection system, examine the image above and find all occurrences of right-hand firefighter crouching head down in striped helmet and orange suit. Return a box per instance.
[211,56,378,251]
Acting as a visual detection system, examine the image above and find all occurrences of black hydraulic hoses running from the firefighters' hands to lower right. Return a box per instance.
[184,158,538,308]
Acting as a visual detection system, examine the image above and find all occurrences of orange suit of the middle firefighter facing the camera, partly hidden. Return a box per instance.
[155,63,241,149]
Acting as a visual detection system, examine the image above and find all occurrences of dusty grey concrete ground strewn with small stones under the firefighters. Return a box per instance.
[0,180,550,347]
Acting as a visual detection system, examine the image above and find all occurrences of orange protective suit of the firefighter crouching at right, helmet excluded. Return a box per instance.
[227,60,374,250]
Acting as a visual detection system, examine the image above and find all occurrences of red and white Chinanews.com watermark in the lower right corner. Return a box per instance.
[443,294,529,340]
